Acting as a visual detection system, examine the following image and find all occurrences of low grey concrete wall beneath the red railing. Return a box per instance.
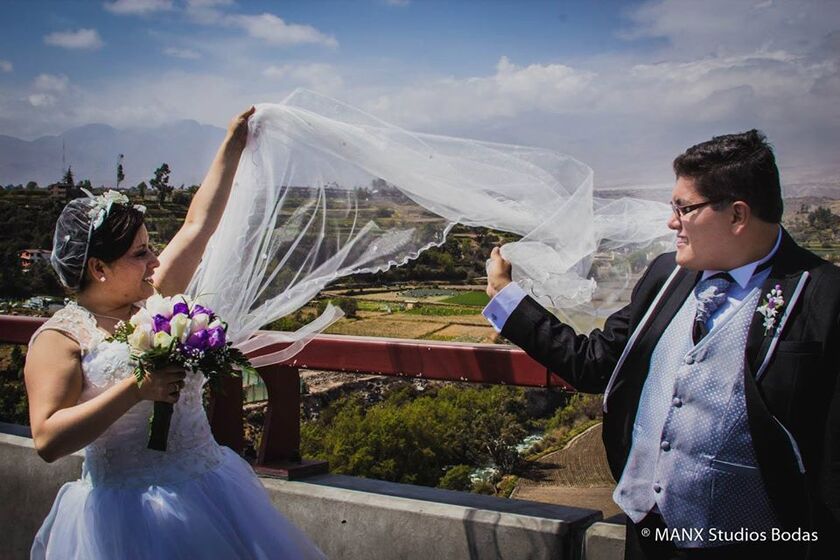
[0,433,624,560]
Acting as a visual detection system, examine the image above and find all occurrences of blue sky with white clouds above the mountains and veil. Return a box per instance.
[0,0,840,189]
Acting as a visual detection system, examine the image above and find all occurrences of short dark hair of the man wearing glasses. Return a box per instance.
[674,129,784,223]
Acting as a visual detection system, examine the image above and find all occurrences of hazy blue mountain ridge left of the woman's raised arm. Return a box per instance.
[0,120,225,187]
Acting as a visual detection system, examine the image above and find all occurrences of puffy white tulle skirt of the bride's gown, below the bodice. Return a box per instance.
[31,448,324,560]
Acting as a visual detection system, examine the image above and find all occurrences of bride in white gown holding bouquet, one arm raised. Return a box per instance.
[25,107,323,559]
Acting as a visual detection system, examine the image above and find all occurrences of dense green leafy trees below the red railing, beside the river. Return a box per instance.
[301,385,530,488]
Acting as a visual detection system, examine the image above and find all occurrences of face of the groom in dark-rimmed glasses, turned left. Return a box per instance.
[668,177,733,270]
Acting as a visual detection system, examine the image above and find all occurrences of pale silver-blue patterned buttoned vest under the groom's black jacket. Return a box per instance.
[613,288,778,548]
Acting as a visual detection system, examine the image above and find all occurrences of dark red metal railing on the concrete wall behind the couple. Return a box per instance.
[0,315,571,478]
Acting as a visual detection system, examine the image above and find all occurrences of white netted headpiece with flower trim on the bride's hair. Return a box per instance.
[50,189,146,290]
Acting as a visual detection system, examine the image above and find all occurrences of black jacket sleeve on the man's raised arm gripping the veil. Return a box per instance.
[502,256,664,393]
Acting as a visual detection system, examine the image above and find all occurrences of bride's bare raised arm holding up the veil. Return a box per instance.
[152,107,254,295]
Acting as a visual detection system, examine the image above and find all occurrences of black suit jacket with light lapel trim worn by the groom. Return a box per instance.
[502,231,840,558]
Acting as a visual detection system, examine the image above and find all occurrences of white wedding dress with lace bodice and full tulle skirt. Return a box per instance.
[32,303,324,560]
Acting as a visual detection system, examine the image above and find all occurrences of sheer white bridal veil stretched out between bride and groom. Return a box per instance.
[190,90,670,365]
